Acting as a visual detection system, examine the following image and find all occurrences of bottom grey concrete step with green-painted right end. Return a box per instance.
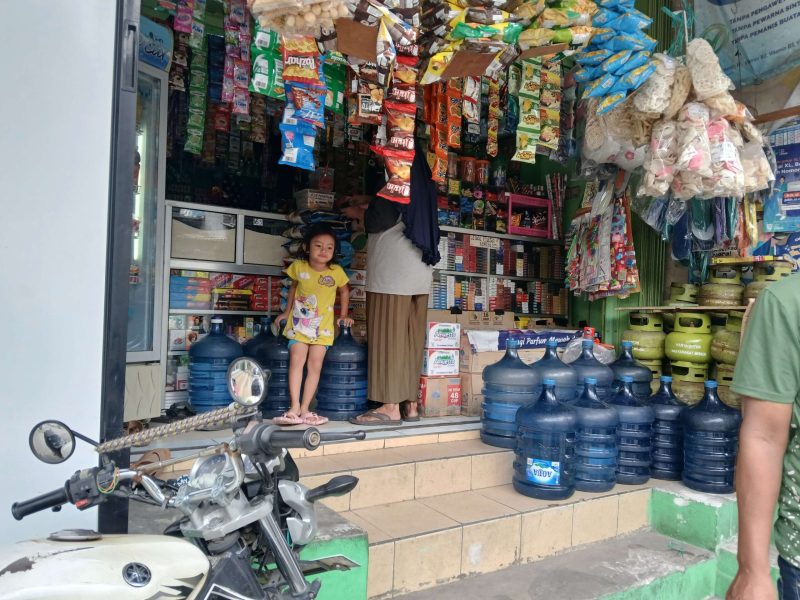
[394,531,715,600]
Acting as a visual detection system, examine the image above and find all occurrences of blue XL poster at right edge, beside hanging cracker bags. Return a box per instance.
[764,127,800,233]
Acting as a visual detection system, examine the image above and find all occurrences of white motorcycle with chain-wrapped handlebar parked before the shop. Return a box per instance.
[0,358,365,600]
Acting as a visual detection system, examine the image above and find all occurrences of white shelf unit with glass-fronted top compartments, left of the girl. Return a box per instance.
[161,200,287,408]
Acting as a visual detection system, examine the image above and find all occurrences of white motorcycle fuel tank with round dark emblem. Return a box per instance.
[0,532,209,600]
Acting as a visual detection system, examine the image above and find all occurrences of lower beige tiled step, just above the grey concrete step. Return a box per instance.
[340,484,650,598]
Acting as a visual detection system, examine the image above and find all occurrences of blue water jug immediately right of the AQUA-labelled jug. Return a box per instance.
[572,377,619,492]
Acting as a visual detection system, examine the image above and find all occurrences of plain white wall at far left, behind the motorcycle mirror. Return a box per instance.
[0,0,116,543]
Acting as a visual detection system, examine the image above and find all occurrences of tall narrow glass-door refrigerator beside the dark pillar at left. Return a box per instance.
[127,63,168,364]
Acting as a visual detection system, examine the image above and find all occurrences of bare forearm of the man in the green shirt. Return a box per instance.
[727,397,792,600]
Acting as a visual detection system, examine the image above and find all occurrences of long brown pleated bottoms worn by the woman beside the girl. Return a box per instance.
[367,292,428,404]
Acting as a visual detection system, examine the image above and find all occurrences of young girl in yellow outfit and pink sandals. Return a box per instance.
[274,224,353,425]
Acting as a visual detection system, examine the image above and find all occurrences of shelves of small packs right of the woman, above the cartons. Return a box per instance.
[429,226,569,317]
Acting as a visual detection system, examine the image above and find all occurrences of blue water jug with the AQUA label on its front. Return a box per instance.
[513,379,578,500]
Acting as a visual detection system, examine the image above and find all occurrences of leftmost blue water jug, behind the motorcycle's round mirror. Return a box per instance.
[189,317,242,412]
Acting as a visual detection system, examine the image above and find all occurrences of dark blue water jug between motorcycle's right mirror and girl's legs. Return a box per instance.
[243,317,291,418]
